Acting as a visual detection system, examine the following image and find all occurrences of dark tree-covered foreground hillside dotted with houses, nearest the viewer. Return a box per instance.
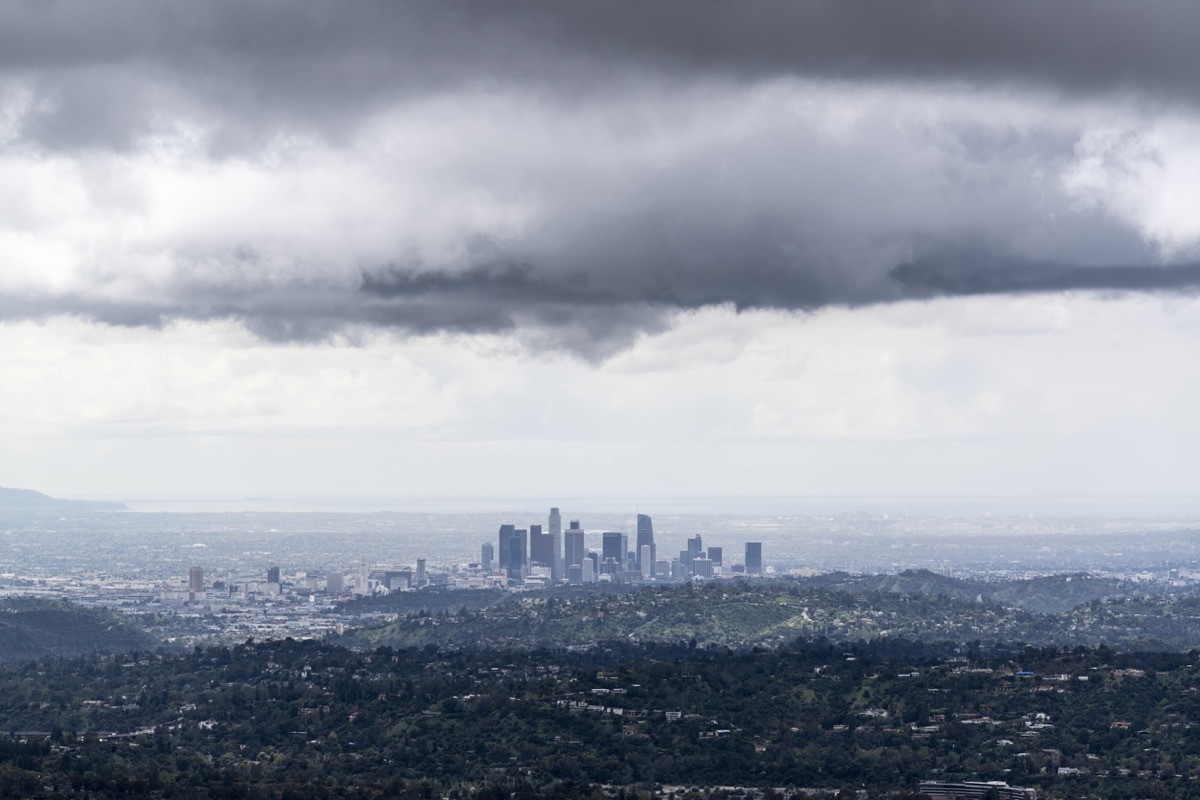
[0,640,1200,798]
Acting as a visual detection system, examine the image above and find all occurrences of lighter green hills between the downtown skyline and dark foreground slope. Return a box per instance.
[338,572,1200,651]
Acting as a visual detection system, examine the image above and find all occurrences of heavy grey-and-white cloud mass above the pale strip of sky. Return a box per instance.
[0,0,1200,356]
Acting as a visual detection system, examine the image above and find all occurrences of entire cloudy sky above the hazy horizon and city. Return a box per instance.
[0,0,1200,511]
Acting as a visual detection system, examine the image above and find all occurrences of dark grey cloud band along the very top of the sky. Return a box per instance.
[0,0,1200,148]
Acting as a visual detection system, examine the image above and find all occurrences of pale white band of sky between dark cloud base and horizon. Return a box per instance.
[0,295,1200,497]
